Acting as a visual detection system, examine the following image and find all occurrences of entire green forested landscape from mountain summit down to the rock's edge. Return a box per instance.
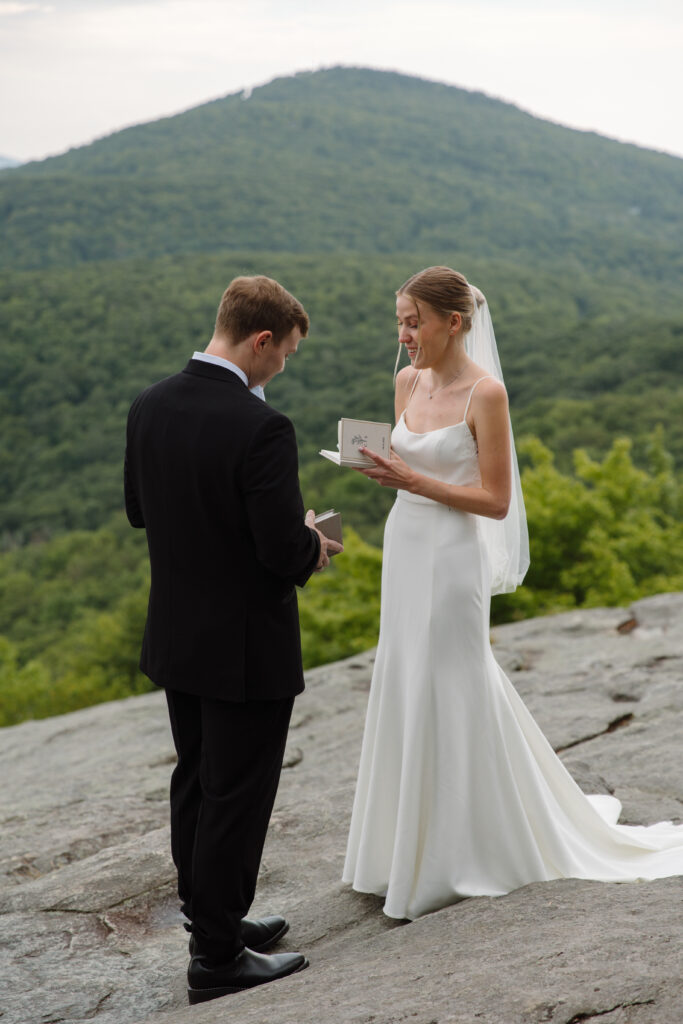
[0,69,683,722]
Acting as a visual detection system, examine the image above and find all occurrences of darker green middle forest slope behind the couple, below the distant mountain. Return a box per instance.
[0,253,683,547]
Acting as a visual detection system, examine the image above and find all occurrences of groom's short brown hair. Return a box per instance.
[216,274,310,345]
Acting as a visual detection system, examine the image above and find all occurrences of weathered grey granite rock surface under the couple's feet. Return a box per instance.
[0,594,683,1024]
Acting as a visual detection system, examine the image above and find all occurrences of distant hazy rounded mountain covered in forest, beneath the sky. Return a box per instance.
[0,69,683,281]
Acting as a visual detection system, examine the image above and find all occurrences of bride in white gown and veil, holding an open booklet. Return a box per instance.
[343,266,683,920]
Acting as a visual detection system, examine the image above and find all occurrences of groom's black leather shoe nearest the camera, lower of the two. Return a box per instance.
[187,948,308,1005]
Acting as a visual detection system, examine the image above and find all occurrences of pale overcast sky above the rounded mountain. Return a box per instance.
[0,0,683,160]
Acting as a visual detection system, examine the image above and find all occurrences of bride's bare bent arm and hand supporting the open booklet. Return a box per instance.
[358,378,511,519]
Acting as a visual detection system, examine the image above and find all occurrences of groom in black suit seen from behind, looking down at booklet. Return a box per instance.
[125,276,342,1002]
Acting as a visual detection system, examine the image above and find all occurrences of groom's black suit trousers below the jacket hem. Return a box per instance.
[166,689,294,962]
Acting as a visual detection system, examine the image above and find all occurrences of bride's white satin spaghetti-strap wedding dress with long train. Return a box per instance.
[343,382,683,919]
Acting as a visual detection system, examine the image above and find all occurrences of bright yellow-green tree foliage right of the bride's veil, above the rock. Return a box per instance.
[494,431,683,622]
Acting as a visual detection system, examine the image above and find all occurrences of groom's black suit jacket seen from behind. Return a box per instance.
[125,359,319,700]
